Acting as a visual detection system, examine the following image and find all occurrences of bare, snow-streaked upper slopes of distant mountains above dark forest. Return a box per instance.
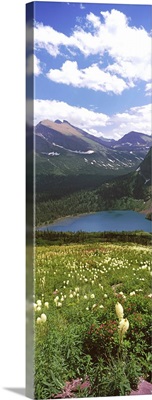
[35,120,152,175]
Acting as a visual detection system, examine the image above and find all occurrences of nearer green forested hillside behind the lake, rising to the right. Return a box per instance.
[36,150,151,225]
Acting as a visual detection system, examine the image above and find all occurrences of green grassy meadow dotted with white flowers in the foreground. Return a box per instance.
[34,242,152,399]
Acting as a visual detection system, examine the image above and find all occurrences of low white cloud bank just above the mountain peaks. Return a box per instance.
[33,100,151,139]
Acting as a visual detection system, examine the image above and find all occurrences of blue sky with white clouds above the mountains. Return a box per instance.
[27,2,152,139]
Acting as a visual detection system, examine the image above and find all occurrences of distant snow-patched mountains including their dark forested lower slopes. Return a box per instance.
[35,119,152,217]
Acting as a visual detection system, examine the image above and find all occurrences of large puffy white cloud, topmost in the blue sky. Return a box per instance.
[34,9,151,86]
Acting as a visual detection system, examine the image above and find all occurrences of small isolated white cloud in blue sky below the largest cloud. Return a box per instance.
[47,61,128,94]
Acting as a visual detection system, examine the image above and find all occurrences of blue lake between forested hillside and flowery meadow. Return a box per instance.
[39,211,152,232]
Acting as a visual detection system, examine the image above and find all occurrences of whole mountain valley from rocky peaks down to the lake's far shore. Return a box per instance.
[35,120,152,226]
